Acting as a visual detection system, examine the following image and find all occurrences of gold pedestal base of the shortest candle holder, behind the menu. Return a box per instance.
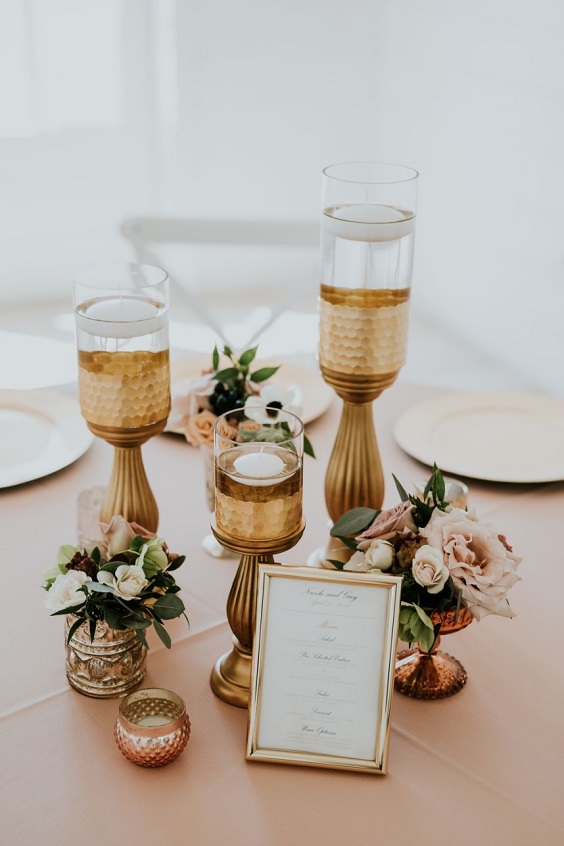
[210,517,305,708]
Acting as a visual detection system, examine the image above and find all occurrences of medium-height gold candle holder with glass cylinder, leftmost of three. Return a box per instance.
[74,263,170,532]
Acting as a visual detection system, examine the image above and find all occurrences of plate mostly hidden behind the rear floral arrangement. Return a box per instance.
[168,355,335,435]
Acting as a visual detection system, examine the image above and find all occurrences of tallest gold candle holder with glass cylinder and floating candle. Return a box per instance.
[319,162,418,520]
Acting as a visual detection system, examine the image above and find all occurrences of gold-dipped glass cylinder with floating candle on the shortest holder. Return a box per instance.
[214,406,303,540]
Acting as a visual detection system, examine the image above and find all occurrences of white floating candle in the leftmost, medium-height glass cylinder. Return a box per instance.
[76,296,167,338]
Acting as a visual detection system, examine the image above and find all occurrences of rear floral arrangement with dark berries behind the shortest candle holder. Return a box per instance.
[168,346,315,457]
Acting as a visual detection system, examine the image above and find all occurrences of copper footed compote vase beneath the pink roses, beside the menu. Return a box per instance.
[394,608,474,699]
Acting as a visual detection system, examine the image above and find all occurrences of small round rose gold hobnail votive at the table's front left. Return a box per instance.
[114,687,191,767]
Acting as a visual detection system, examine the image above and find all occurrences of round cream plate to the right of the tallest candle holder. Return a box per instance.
[394,392,564,483]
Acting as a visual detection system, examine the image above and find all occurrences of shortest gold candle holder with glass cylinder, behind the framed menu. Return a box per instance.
[210,408,305,708]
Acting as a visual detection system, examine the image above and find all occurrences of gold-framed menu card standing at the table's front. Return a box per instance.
[246,564,402,775]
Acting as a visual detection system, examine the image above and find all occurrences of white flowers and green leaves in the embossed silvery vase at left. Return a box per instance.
[43,516,188,649]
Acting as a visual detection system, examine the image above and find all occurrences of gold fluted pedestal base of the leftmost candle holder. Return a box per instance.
[87,419,166,532]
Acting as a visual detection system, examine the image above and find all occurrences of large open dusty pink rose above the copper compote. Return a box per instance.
[420,508,521,620]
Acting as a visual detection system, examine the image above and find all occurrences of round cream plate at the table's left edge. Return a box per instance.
[0,390,94,488]
